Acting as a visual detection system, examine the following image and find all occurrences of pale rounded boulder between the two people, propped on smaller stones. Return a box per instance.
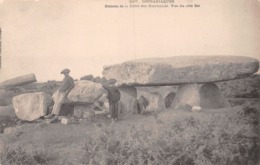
[66,80,107,104]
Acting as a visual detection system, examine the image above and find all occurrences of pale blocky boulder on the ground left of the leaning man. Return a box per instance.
[12,92,51,121]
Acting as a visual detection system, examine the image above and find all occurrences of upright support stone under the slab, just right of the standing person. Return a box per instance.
[118,86,138,114]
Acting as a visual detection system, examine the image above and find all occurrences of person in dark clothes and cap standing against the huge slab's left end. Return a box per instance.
[102,79,121,121]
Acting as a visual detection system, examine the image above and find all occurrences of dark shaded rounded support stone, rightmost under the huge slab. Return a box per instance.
[200,83,231,109]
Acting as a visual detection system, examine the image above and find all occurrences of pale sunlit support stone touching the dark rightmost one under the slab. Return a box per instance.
[172,84,200,108]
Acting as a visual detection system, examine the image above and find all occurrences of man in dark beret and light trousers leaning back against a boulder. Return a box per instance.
[45,69,74,122]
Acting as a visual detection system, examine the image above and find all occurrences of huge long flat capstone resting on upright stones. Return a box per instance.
[103,56,259,86]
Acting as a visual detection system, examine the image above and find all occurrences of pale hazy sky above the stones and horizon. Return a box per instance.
[0,0,260,82]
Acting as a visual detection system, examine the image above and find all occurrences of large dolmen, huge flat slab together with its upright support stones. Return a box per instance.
[102,56,259,111]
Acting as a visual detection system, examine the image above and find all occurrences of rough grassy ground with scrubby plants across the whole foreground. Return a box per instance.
[0,99,259,165]
